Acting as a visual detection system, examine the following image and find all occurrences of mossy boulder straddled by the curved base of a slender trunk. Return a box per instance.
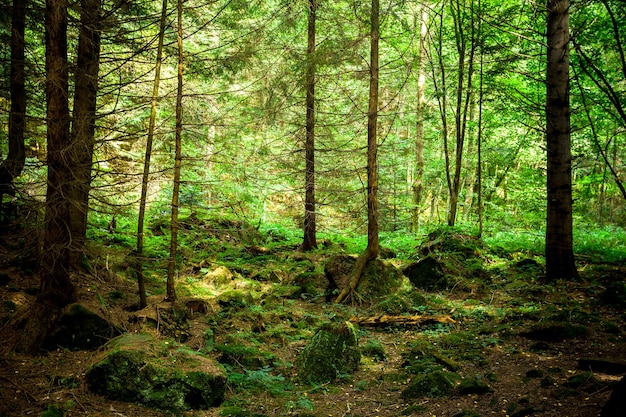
[324,255,405,302]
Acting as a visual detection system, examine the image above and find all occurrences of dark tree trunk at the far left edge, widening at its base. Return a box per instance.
[0,0,26,202]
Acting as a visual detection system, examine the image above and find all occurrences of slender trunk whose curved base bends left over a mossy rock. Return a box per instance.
[336,0,380,303]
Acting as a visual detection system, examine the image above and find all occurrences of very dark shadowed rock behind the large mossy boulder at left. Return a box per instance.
[42,304,122,350]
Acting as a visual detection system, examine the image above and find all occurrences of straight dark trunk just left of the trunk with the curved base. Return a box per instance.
[302,0,317,251]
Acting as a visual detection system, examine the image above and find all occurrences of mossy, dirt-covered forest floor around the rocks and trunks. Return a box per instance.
[0,223,626,417]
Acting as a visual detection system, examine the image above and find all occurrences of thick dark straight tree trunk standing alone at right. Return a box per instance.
[546,0,578,280]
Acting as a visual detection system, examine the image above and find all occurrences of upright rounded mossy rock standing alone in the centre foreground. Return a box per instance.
[296,322,361,384]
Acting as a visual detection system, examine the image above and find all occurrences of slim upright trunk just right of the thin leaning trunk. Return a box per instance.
[167,0,183,301]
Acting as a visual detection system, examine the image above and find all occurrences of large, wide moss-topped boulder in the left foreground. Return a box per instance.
[86,333,226,412]
